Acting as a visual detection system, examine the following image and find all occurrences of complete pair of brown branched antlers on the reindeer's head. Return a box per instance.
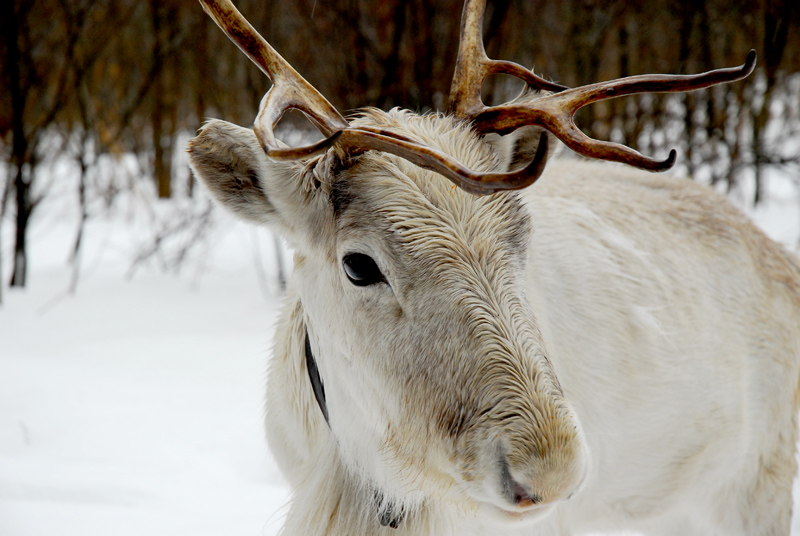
[200,0,756,194]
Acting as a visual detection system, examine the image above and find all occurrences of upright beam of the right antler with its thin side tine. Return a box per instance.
[448,0,567,119]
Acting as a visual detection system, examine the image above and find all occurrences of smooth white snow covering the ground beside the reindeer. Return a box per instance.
[0,163,800,536]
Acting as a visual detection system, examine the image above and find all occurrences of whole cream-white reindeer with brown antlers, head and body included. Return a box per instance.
[189,0,800,536]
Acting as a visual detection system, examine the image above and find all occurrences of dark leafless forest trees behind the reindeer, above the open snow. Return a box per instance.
[0,0,800,294]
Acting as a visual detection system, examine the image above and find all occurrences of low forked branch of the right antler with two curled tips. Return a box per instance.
[474,50,756,171]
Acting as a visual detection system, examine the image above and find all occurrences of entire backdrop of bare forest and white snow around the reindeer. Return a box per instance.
[0,0,800,536]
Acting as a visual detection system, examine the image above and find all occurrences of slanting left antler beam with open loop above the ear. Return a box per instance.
[200,0,348,158]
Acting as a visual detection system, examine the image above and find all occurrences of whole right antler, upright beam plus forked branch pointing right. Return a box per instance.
[450,0,756,177]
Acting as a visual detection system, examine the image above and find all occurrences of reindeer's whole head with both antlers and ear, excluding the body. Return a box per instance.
[189,0,755,519]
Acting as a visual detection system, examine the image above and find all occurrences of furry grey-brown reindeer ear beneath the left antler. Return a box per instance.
[188,119,296,224]
